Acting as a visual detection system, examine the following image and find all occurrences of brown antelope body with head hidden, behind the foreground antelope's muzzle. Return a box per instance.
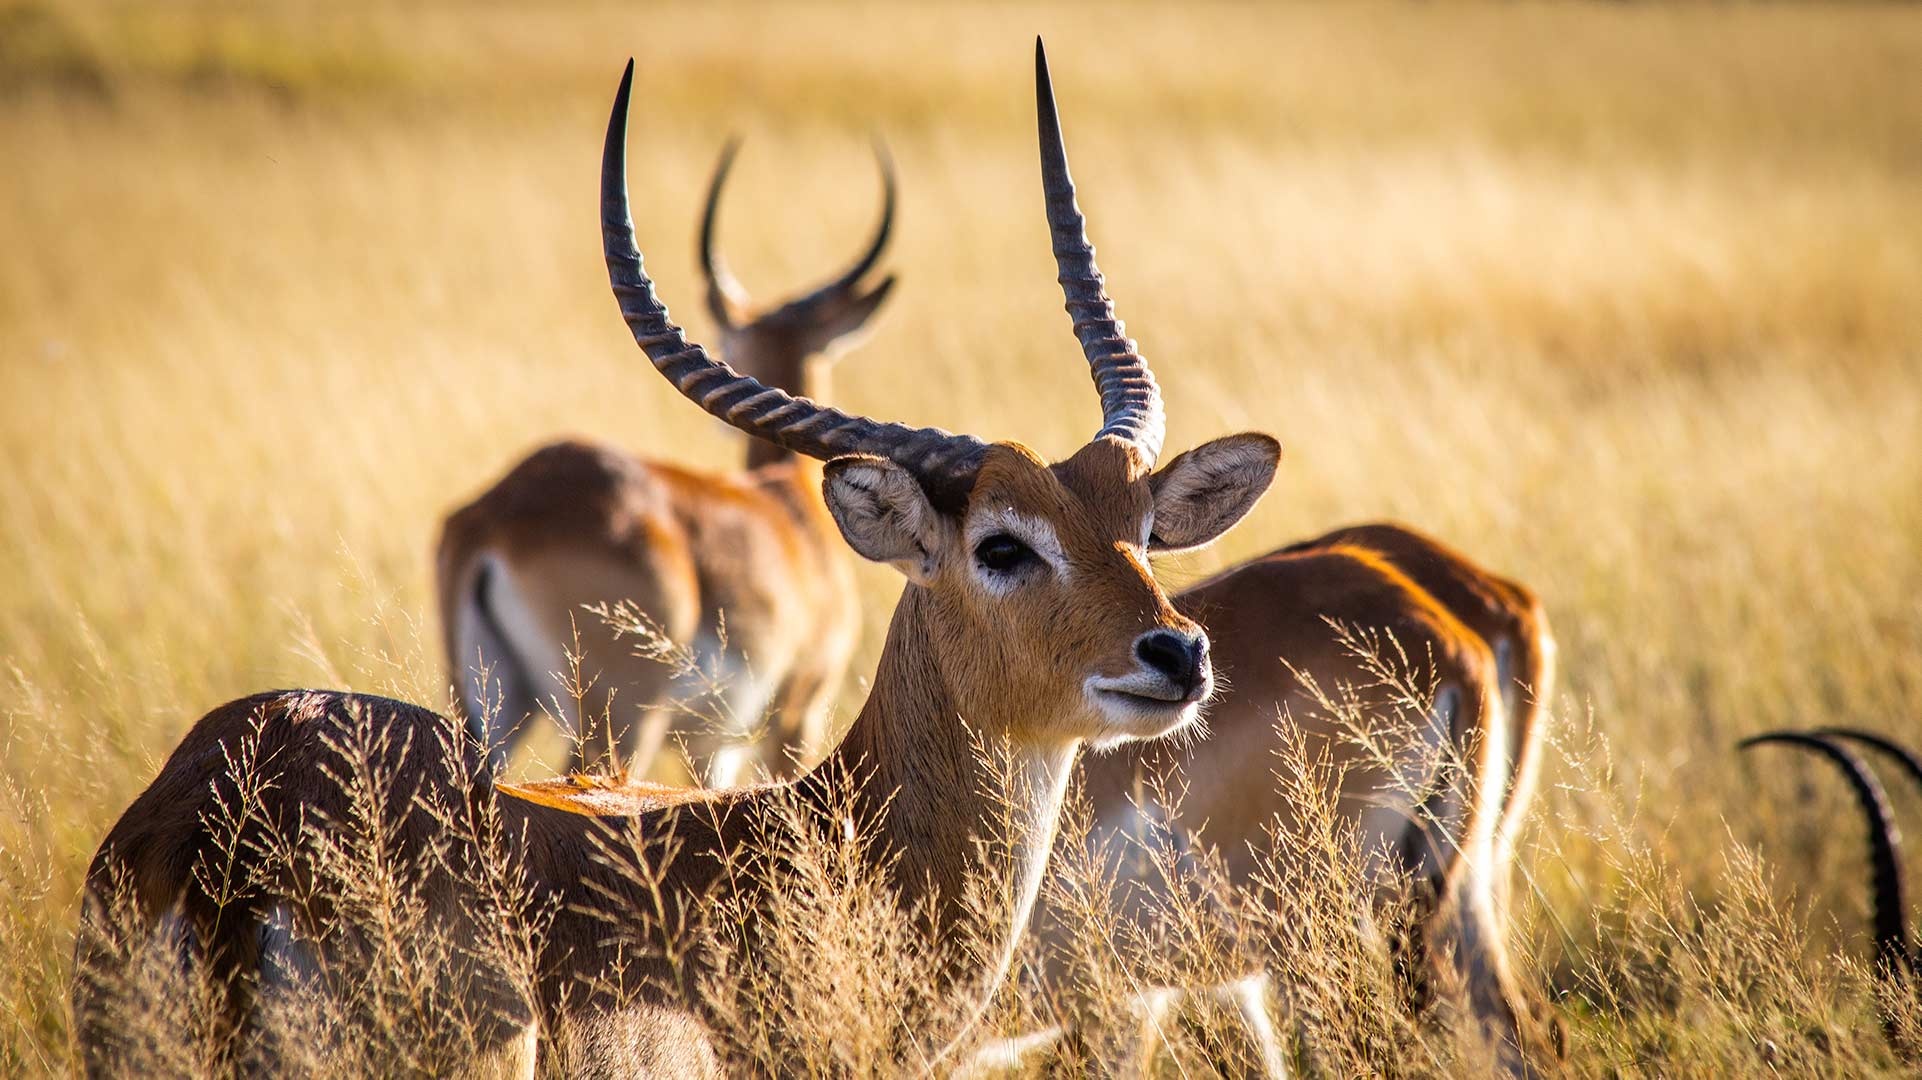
[1040,525,1555,1072]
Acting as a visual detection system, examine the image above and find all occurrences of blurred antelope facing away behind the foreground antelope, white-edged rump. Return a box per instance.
[436,142,894,788]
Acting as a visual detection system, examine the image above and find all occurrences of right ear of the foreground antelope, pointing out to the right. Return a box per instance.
[1147,432,1282,552]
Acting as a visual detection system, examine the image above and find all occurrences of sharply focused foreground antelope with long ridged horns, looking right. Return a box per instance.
[75,46,1280,1074]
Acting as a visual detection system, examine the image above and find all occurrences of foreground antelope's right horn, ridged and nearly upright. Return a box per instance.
[1034,38,1167,465]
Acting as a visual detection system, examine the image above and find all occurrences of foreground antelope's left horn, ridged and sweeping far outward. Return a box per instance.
[602,60,988,509]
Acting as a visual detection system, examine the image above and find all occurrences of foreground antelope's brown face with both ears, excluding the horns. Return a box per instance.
[826,434,1280,748]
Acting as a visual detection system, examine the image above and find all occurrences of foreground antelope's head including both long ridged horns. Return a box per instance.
[602,42,1280,746]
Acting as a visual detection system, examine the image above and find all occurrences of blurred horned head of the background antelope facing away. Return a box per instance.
[700,138,894,386]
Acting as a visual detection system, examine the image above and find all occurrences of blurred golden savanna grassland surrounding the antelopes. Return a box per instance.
[0,0,1922,1074]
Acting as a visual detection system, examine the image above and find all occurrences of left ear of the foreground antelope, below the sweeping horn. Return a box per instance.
[821,454,955,584]
